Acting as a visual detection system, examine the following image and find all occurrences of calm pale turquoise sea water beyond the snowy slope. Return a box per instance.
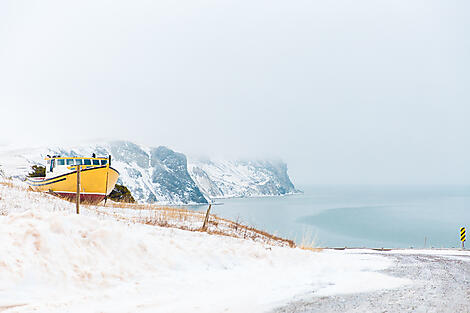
[189,186,470,248]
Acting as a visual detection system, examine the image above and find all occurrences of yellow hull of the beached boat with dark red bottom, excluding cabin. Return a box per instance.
[27,166,119,204]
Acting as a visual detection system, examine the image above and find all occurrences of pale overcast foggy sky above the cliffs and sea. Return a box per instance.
[0,0,470,184]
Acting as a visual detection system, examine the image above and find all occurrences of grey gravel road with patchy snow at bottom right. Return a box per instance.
[272,251,470,313]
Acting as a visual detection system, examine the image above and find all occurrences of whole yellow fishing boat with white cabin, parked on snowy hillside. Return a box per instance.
[26,155,119,203]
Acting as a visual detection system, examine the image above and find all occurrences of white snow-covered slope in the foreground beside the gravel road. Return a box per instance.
[0,185,410,313]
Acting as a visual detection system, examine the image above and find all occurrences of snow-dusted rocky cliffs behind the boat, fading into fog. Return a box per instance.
[0,141,297,204]
